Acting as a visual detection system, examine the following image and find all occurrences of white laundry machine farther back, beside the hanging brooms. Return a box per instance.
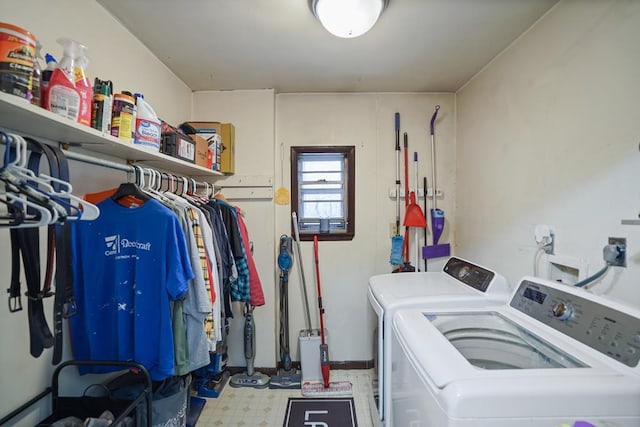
[368,257,511,425]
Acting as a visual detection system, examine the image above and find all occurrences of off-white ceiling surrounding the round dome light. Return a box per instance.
[98,0,557,93]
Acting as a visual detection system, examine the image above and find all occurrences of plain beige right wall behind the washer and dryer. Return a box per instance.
[455,0,640,306]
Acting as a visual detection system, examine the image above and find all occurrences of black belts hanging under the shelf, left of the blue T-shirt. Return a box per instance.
[9,138,76,364]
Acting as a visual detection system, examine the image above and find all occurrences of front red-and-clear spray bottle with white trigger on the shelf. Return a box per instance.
[44,38,81,122]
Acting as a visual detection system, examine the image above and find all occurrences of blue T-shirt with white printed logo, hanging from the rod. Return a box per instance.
[71,198,193,380]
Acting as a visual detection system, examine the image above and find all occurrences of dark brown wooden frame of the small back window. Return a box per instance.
[290,145,356,241]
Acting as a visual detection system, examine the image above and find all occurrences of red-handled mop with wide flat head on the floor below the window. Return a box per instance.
[302,236,353,397]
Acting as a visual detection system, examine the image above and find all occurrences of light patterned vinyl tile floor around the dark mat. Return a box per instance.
[196,369,373,427]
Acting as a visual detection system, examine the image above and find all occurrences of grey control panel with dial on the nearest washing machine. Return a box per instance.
[510,280,640,368]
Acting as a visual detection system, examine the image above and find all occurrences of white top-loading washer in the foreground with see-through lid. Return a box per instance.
[390,277,640,427]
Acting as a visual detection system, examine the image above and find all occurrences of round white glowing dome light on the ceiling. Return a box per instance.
[309,0,389,39]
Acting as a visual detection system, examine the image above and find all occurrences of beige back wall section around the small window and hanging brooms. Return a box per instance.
[275,93,455,361]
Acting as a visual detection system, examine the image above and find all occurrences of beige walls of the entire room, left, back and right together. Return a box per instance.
[0,0,640,425]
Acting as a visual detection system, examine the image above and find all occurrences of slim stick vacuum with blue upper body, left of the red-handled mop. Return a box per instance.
[269,234,302,389]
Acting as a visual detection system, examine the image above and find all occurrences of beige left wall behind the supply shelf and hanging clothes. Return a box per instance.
[0,0,191,426]
